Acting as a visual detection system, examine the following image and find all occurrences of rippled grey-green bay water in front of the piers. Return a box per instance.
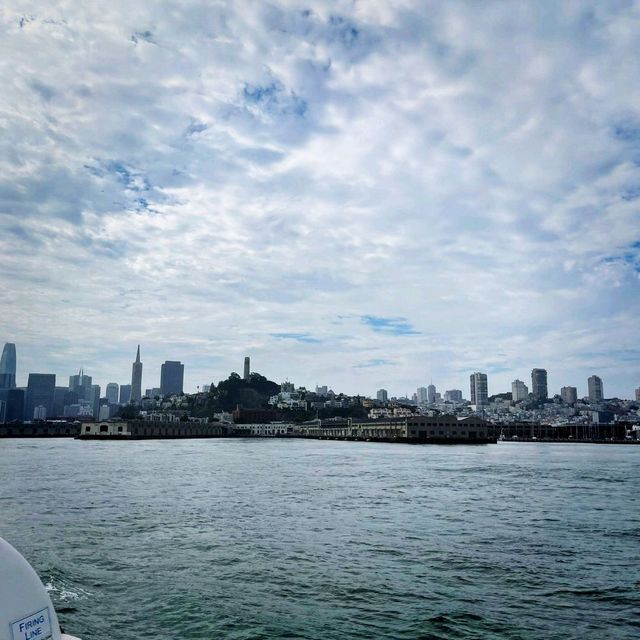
[0,439,640,640]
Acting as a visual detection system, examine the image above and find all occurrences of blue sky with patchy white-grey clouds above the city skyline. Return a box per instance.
[0,0,640,397]
